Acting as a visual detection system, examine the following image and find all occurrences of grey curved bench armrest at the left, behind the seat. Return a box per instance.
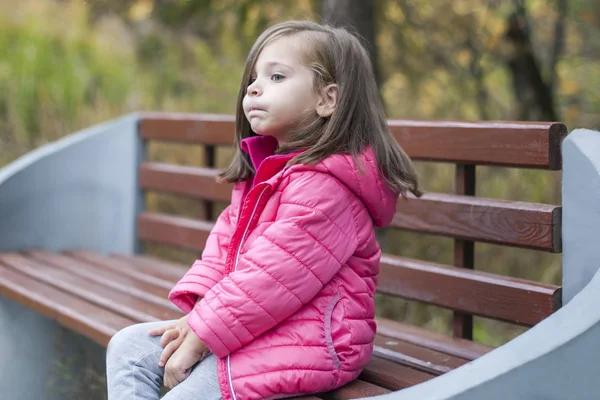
[0,115,143,253]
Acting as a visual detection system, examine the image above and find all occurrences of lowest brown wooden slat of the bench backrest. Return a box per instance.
[134,214,560,326]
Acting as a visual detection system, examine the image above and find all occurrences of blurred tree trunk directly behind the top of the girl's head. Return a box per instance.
[321,0,381,86]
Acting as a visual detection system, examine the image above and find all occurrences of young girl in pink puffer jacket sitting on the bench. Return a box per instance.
[107,22,418,400]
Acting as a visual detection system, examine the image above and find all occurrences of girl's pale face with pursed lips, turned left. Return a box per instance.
[242,37,319,143]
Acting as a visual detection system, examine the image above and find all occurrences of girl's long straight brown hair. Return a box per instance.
[220,21,420,196]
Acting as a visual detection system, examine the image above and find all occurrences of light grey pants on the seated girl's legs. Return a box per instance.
[106,321,221,400]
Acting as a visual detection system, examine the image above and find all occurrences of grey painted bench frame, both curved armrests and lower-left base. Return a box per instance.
[0,114,600,400]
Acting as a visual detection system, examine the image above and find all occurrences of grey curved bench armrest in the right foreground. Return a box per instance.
[364,129,600,400]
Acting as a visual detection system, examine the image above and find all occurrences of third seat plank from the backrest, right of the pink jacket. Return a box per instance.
[360,356,437,390]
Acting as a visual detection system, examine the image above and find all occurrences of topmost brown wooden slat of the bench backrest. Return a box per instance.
[140,113,567,170]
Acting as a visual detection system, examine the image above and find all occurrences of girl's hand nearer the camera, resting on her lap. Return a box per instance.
[163,332,209,389]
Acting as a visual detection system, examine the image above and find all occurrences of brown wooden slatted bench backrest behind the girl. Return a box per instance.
[138,114,567,339]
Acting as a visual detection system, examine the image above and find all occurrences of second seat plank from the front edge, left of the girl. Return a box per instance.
[0,254,181,322]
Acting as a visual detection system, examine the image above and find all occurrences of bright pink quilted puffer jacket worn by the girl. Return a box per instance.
[169,142,397,400]
